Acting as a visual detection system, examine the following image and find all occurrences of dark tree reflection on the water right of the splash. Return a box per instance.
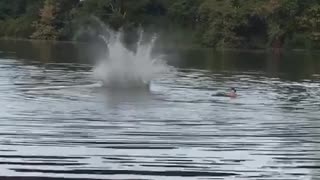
[173,49,320,80]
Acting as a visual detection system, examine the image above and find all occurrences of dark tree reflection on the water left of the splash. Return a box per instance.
[0,40,106,64]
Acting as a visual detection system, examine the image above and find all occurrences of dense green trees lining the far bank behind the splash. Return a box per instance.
[0,0,320,49]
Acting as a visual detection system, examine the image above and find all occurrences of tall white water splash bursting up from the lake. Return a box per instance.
[94,29,172,88]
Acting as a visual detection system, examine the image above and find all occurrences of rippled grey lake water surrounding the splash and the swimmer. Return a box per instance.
[0,41,320,180]
